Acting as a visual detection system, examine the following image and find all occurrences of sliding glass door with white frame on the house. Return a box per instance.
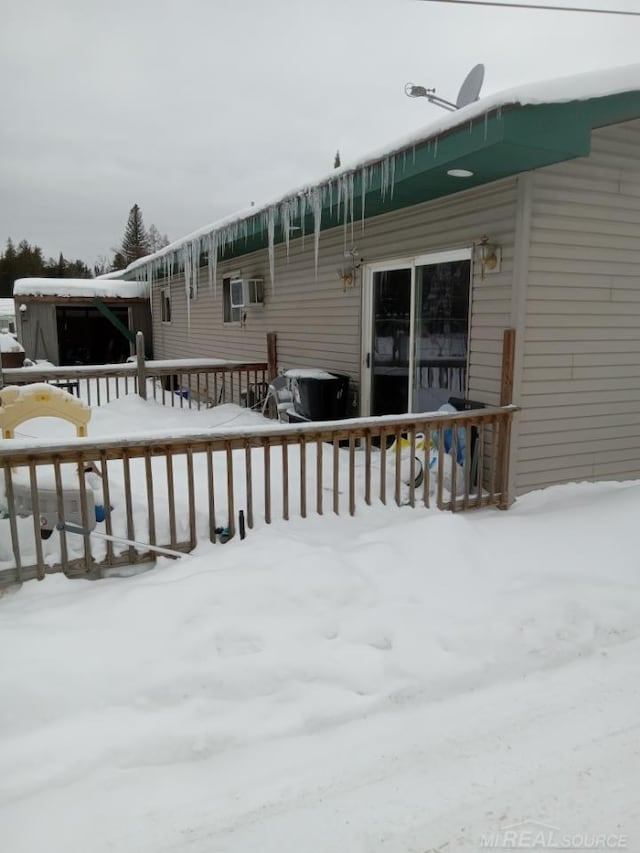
[363,249,471,415]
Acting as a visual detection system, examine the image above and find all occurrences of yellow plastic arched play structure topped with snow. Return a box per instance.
[0,382,91,438]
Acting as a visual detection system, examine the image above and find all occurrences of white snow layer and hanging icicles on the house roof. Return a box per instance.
[125,63,640,284]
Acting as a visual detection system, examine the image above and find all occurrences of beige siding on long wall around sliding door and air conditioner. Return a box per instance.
[154,179,516,412]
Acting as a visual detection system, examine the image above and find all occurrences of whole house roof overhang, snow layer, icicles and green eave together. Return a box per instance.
[124,64,640,284]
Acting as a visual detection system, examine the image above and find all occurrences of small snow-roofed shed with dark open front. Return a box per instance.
[13,278,152,365]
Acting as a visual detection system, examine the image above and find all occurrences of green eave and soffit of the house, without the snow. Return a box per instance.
[126,91,640,278]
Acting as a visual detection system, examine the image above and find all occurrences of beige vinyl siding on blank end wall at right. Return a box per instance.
[516,121,640,493]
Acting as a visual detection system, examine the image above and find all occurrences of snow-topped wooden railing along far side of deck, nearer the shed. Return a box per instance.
[0,358,268,409]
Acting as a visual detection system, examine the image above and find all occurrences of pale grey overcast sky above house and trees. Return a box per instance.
[0,0,640,265]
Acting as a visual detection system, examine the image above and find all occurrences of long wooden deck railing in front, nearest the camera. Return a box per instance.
[0,406,515,585]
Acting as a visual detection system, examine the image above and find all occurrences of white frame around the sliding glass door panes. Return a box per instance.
[360,246,473,417]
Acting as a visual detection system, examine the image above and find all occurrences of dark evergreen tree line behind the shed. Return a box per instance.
[0,204,169,297]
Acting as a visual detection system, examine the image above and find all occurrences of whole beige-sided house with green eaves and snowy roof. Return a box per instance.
[117,65,640,495]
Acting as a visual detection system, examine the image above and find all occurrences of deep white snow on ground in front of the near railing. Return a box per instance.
[0,396,640,853]
